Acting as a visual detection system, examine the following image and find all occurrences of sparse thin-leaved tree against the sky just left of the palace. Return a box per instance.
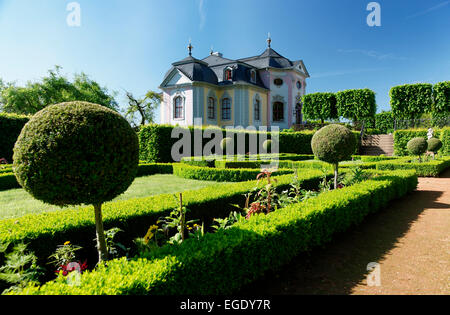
[125,91,161,127]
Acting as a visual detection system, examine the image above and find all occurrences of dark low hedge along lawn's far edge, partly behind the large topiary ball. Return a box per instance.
[0,163,173,191]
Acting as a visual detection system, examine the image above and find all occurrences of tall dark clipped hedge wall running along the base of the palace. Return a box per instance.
[139,124,360,163]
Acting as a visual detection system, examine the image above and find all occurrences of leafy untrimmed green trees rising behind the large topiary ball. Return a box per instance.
[0,66,118,115]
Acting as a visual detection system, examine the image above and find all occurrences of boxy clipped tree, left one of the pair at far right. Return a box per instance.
[389,83,433,119]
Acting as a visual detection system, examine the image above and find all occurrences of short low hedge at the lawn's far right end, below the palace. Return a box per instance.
[173,163,293,182]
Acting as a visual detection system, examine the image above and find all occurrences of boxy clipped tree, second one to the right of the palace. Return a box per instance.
[336,89,377,121]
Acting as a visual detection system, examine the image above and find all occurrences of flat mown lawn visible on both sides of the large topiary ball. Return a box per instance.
[0,175,216,220]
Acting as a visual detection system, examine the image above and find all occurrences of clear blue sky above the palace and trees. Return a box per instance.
[0,0,450,122]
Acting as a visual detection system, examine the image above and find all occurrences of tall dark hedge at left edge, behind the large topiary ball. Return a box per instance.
[0,113,29,163]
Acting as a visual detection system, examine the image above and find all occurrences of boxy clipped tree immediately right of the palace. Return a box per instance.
[303,93,338,124]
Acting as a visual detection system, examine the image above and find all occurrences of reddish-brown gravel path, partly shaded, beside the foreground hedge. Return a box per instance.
[241,170,450,295]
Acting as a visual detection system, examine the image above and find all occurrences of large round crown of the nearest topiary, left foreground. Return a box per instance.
[14,102,139,207]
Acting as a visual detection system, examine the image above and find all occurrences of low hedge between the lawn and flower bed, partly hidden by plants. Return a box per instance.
[0,170,331,265]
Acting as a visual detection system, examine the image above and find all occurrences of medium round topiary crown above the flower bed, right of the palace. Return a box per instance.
[311,124,356,164]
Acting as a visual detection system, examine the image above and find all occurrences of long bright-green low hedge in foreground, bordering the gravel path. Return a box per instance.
[14,171,417,295]
